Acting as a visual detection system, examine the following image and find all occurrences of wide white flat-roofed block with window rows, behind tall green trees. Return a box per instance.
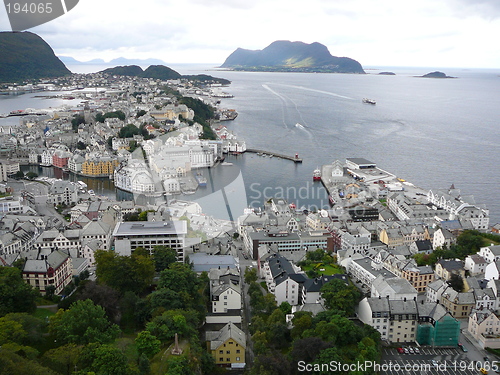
[113,220,187,262]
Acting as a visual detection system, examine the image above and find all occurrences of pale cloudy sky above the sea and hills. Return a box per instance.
[0,0,500,68]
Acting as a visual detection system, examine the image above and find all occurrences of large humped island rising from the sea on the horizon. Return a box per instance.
[221,40,365,74]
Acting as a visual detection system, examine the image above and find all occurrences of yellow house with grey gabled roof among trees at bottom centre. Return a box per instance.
[206,323,246,368]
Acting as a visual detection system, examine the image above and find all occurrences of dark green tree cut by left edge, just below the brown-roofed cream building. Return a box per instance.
[0,267,40,317]
